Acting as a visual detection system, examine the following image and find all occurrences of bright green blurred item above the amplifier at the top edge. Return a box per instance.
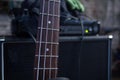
[67,0,85,12]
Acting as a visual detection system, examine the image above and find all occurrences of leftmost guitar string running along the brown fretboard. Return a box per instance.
[36,0,45,80]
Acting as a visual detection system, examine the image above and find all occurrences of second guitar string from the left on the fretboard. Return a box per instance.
[43,0,50,80]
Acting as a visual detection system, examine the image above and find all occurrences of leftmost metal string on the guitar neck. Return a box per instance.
[36,0,45,80]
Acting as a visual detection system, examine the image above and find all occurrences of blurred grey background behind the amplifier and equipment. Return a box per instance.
[0,0,120,80]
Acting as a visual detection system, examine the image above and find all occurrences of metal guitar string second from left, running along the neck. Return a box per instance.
[43,0,50,80]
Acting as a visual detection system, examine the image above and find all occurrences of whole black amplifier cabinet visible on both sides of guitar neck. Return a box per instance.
[0,36,111,80]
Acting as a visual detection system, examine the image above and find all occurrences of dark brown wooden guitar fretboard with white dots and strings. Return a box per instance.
[34,0,60,80]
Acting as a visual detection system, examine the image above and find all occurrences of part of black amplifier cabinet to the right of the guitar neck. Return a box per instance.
[58,36,112,80]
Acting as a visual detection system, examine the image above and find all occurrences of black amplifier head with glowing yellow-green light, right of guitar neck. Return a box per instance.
[60,21,100,36]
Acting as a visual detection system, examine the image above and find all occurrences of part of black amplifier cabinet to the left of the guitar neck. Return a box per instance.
[0,37,35,80]
